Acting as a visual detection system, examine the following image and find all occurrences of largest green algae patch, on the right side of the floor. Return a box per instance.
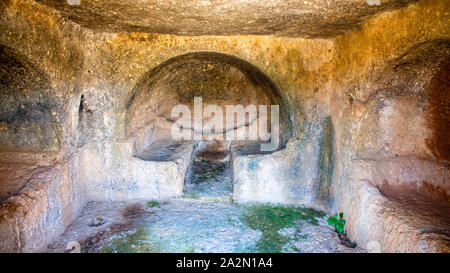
[241,205,325,253]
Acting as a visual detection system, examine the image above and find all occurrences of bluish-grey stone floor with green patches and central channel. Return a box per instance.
[44,155,364,253]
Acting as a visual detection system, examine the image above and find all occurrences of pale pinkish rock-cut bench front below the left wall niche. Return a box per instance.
[0,162,87,252]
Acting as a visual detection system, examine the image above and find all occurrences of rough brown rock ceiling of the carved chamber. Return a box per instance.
[38,0,413,37]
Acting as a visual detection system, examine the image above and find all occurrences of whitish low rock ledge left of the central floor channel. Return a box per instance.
[78,142,193,201]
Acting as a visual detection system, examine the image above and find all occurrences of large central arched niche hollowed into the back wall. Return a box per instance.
[126,52,292,158]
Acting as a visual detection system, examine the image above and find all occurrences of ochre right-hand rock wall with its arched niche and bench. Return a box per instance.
[330,1,449,252]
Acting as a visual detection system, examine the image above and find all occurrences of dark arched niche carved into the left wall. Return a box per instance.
[0,43,63,151]
